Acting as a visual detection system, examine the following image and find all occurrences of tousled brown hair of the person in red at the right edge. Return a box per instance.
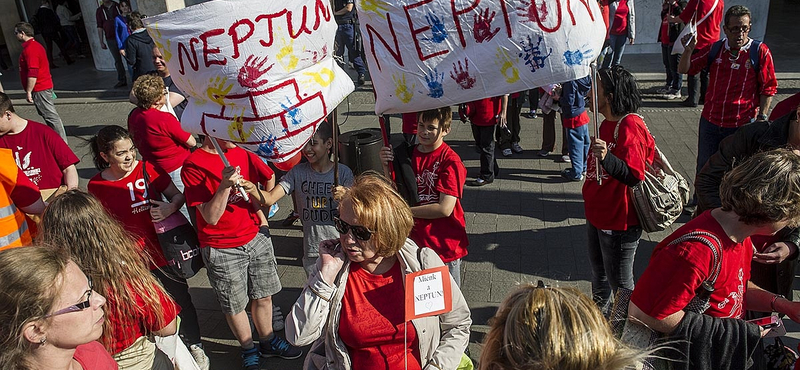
[719,149,800,227]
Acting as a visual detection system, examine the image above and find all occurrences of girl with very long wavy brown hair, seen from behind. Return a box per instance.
[41,190,179,370]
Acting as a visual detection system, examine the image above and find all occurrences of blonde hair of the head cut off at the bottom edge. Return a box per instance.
[480,284,645,370]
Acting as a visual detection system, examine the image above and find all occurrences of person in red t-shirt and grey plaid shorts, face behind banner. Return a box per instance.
[181,136,302,370]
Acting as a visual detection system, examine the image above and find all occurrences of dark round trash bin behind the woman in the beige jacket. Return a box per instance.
[339,128,383,175]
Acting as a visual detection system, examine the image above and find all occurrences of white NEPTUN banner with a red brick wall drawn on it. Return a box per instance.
[144,0,354,163]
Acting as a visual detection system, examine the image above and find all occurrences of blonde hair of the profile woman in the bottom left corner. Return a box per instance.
[0,246,69,370]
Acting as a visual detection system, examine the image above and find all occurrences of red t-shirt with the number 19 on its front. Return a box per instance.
[88,161,172,270]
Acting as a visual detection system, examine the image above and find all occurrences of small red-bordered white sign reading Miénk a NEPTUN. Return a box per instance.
[406,266,453,321]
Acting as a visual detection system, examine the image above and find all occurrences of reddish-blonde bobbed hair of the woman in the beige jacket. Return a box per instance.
[334,171,414,257]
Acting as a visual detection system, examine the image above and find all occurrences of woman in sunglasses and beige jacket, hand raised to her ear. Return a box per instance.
[286,174,472,369]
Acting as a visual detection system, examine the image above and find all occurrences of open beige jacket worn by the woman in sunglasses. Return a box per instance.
[286,239,472,370]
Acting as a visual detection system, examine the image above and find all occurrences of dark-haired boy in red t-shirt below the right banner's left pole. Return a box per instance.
[381,107,469,287]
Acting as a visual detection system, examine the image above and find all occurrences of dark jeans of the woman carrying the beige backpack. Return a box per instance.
[586,221,642,313]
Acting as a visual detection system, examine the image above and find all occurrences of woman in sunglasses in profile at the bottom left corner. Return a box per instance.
[0,246,117,370]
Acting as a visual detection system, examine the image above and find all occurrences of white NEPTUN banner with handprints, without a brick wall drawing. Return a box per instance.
[356,0,606,114]
